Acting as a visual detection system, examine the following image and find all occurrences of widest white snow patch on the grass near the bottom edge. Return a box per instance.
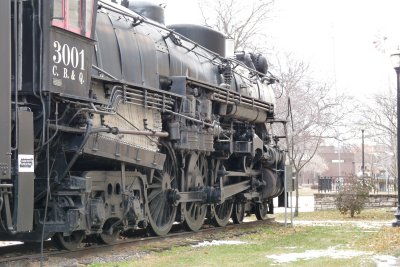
[266,248,372,263]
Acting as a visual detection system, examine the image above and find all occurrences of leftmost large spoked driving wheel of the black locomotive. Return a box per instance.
[147,142,178,236]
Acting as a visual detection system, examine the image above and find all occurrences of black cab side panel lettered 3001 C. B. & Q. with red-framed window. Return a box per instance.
[43,0,97,98]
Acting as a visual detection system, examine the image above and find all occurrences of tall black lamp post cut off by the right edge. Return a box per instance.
[390,52,400,227]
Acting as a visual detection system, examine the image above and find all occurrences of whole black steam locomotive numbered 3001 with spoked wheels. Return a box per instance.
[0,0,285,249]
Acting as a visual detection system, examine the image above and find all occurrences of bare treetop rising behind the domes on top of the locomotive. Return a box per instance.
[198,0,273,51]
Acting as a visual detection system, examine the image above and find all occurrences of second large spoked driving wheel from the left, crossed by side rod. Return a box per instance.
[182,153,208,231]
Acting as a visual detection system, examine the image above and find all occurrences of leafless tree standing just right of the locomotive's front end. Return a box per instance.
[273,52,348,216]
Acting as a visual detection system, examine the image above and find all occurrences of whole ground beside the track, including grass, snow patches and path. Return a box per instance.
[0,187,400,267]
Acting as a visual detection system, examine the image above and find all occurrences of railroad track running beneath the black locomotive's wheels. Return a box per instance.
[0,219,275,266]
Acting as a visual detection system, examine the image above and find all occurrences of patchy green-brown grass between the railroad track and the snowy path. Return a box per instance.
[90,225,400,267]
